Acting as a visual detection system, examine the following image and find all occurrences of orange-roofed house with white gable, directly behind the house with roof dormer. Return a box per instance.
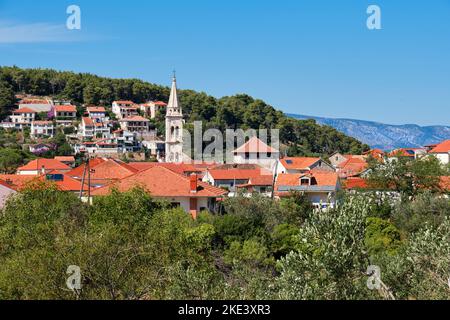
[276,157,335,174]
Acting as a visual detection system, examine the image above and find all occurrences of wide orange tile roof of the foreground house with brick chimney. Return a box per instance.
[92,166,227,198]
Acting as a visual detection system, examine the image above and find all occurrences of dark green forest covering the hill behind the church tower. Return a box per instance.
[0,67,368,156]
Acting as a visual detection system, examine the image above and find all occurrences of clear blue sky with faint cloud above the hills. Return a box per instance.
[0,0,450,125]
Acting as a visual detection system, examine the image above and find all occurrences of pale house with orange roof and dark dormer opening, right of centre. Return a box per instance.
[275,170,341,210]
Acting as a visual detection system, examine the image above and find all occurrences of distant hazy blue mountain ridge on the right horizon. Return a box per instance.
[287,114,450,150]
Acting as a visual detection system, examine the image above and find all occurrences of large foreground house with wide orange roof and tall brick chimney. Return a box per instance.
[92,166,227,218]
